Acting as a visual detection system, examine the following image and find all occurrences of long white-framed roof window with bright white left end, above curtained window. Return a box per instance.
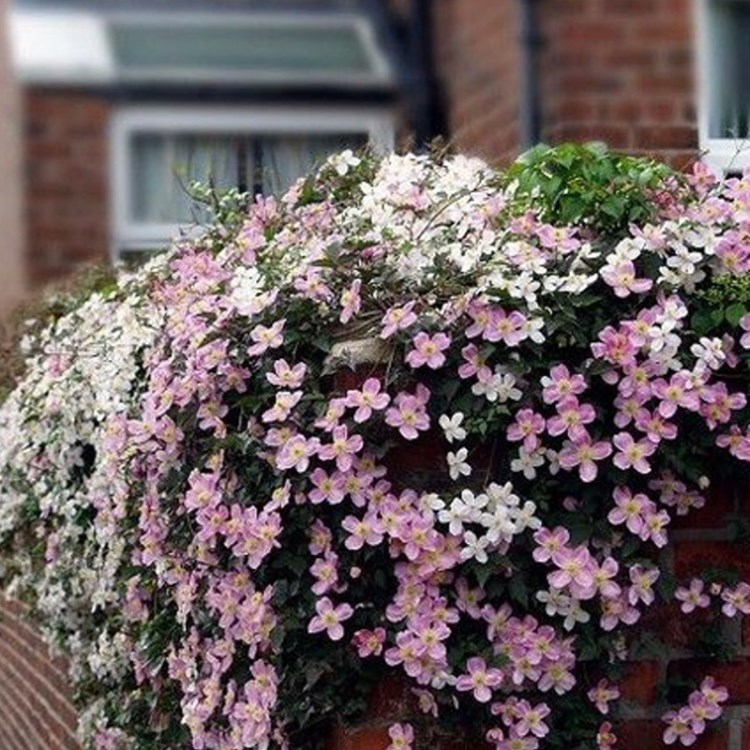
[10,9,393,89]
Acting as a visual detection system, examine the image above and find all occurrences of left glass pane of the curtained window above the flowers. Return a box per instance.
[130,133,246,224]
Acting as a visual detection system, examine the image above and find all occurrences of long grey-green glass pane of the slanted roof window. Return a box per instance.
[110,21,372,77]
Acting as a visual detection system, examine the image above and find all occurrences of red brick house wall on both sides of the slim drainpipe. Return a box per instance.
[435,0,698,167]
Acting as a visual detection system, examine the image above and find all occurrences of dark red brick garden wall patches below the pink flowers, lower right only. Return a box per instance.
[330,484,750,750]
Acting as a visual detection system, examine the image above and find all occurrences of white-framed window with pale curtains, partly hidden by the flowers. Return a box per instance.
[112,107,393,259]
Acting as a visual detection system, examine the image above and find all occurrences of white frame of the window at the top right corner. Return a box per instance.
[693,0,750,177]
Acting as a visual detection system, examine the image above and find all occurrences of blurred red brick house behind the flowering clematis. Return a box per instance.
[0,0,736,308]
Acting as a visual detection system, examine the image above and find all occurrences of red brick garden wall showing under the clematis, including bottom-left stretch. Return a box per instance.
[0,494,750,750]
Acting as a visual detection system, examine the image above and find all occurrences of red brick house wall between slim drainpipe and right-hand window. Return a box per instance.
[539,0,698,167]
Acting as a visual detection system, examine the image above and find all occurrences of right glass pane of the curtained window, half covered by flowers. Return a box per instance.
[256,133,367,194]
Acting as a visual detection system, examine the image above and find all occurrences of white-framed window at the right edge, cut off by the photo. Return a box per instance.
[697,0,750,173]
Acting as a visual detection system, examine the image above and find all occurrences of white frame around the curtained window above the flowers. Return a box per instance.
[110,105,395,261]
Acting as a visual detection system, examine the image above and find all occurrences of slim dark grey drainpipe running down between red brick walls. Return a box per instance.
[519,0,542,151]
